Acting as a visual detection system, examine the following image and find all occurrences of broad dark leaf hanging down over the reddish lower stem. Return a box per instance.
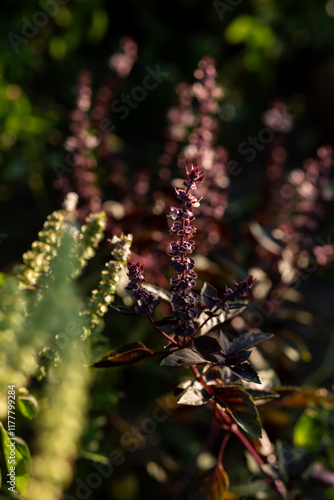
[215,386,262,437]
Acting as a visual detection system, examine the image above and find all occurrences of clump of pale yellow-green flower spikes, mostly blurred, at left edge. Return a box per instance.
[0,200,131,500]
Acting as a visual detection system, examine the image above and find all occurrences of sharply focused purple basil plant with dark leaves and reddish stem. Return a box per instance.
[93,165,287,499]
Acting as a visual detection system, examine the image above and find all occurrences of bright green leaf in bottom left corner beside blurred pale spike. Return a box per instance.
[0,422,30,494]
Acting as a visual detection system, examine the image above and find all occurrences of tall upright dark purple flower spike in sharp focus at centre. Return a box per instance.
[170,166,203,336]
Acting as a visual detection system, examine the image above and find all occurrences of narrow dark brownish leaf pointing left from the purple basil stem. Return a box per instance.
[91,342,157,368]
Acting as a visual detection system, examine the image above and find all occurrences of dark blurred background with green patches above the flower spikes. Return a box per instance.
[0,0,334,269]
